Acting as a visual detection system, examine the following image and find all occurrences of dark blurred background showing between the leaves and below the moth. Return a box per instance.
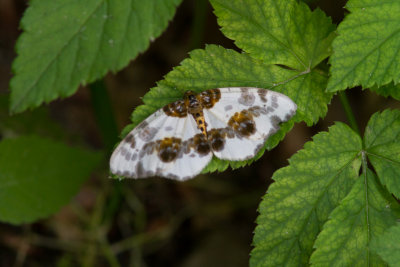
[0,0,395,267]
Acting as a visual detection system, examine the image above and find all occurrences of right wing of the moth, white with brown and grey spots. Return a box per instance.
[204,87,297,160]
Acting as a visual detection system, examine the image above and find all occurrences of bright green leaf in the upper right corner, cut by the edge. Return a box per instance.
[327,0,400,92]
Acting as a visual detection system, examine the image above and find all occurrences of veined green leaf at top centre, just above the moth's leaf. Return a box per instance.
[210,0,335,70]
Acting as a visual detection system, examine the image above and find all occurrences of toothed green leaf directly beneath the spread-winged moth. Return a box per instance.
[122,45,332,175]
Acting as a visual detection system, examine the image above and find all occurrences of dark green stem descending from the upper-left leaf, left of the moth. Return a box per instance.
[89,80,118,151]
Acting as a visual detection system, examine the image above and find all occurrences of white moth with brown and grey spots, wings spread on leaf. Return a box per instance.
[110,87,297,181]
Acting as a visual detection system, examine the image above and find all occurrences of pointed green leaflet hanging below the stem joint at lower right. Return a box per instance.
[310,171,400,266]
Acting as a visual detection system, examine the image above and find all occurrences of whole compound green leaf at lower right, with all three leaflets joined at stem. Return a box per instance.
[250,110,400,266]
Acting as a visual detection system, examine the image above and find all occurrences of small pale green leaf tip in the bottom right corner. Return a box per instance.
[370,224,400,266]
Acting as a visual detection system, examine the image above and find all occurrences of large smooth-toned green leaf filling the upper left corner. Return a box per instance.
[11,0,181,112]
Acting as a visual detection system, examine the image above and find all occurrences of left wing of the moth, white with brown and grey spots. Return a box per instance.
[110,109,212,180]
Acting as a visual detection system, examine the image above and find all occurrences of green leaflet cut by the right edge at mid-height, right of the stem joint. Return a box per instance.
[364,110,400,198]
